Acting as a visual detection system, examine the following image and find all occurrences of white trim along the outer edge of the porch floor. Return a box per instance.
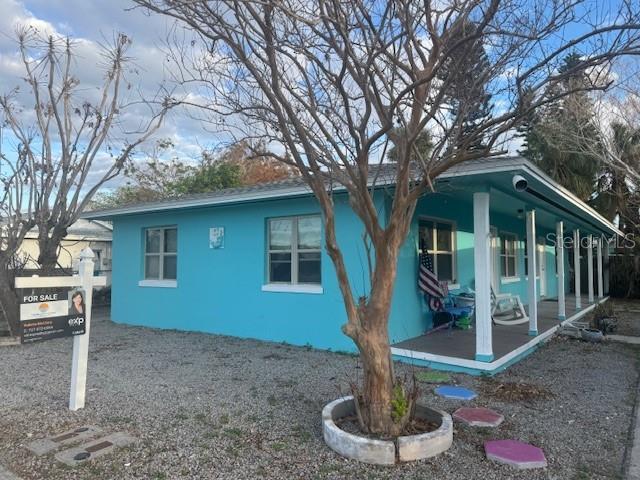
[391,297,609,372]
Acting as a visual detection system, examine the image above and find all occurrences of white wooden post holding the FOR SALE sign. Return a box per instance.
[16,247,107,411]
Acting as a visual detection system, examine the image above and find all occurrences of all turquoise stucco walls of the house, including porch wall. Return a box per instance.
[112,193,568,351]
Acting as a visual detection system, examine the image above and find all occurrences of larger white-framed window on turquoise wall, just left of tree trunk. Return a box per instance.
[268,215,322,285]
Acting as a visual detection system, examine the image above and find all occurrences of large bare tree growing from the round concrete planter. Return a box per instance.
[136,0,640,435]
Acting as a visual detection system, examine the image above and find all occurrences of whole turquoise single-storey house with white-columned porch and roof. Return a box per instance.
[85,157,620,374]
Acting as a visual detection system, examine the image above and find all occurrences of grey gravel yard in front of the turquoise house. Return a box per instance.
[0,304,640,480]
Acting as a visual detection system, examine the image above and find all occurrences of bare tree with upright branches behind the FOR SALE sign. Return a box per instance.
[0,27,175,334]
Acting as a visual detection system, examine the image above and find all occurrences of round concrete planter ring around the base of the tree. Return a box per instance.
[322,396,453,465]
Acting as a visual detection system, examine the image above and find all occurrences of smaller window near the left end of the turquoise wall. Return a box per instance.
[144,227,178,280]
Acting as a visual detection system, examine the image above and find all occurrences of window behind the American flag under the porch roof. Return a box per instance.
[418,220,456,283]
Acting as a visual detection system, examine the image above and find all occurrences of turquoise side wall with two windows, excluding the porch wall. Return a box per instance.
[112,193,384,351]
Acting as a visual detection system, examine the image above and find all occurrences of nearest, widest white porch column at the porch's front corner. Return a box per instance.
[473,192,493,362]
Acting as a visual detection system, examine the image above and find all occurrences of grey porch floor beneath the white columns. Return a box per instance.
[392,295,598,360]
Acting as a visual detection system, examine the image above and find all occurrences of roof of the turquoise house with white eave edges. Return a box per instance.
[82,156,622,235]
